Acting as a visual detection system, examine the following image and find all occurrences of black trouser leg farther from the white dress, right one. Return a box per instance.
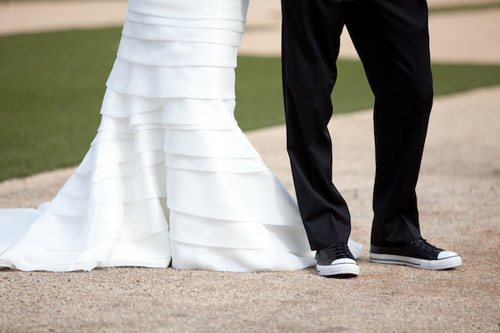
[343,0,433,246]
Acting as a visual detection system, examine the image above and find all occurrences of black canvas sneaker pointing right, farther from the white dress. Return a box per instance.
[370,238,462,269]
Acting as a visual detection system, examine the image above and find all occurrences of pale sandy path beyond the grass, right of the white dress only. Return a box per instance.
[240,0,500,63]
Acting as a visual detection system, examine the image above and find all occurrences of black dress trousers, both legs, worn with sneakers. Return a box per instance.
[282,0,433,250]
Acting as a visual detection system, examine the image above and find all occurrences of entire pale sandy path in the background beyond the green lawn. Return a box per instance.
[0,0,500,63]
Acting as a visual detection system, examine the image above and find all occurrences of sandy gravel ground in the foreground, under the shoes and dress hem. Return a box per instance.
[0,87,500,332]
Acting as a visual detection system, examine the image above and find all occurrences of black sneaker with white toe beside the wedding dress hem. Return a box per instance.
[316,243,359,277]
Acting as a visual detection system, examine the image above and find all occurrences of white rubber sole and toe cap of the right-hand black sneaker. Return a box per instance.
[370,253,462,269]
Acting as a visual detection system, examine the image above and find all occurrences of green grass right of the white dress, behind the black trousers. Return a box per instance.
[236,57,500,130]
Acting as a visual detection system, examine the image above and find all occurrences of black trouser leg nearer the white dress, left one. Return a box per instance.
[282,0,350,250]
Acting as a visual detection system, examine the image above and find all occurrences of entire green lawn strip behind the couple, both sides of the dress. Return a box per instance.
[0,28,500,180]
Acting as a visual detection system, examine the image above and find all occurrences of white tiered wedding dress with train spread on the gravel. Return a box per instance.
[0,0,360,272]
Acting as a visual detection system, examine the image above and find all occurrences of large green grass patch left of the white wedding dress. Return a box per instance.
[0,29,120,180]
